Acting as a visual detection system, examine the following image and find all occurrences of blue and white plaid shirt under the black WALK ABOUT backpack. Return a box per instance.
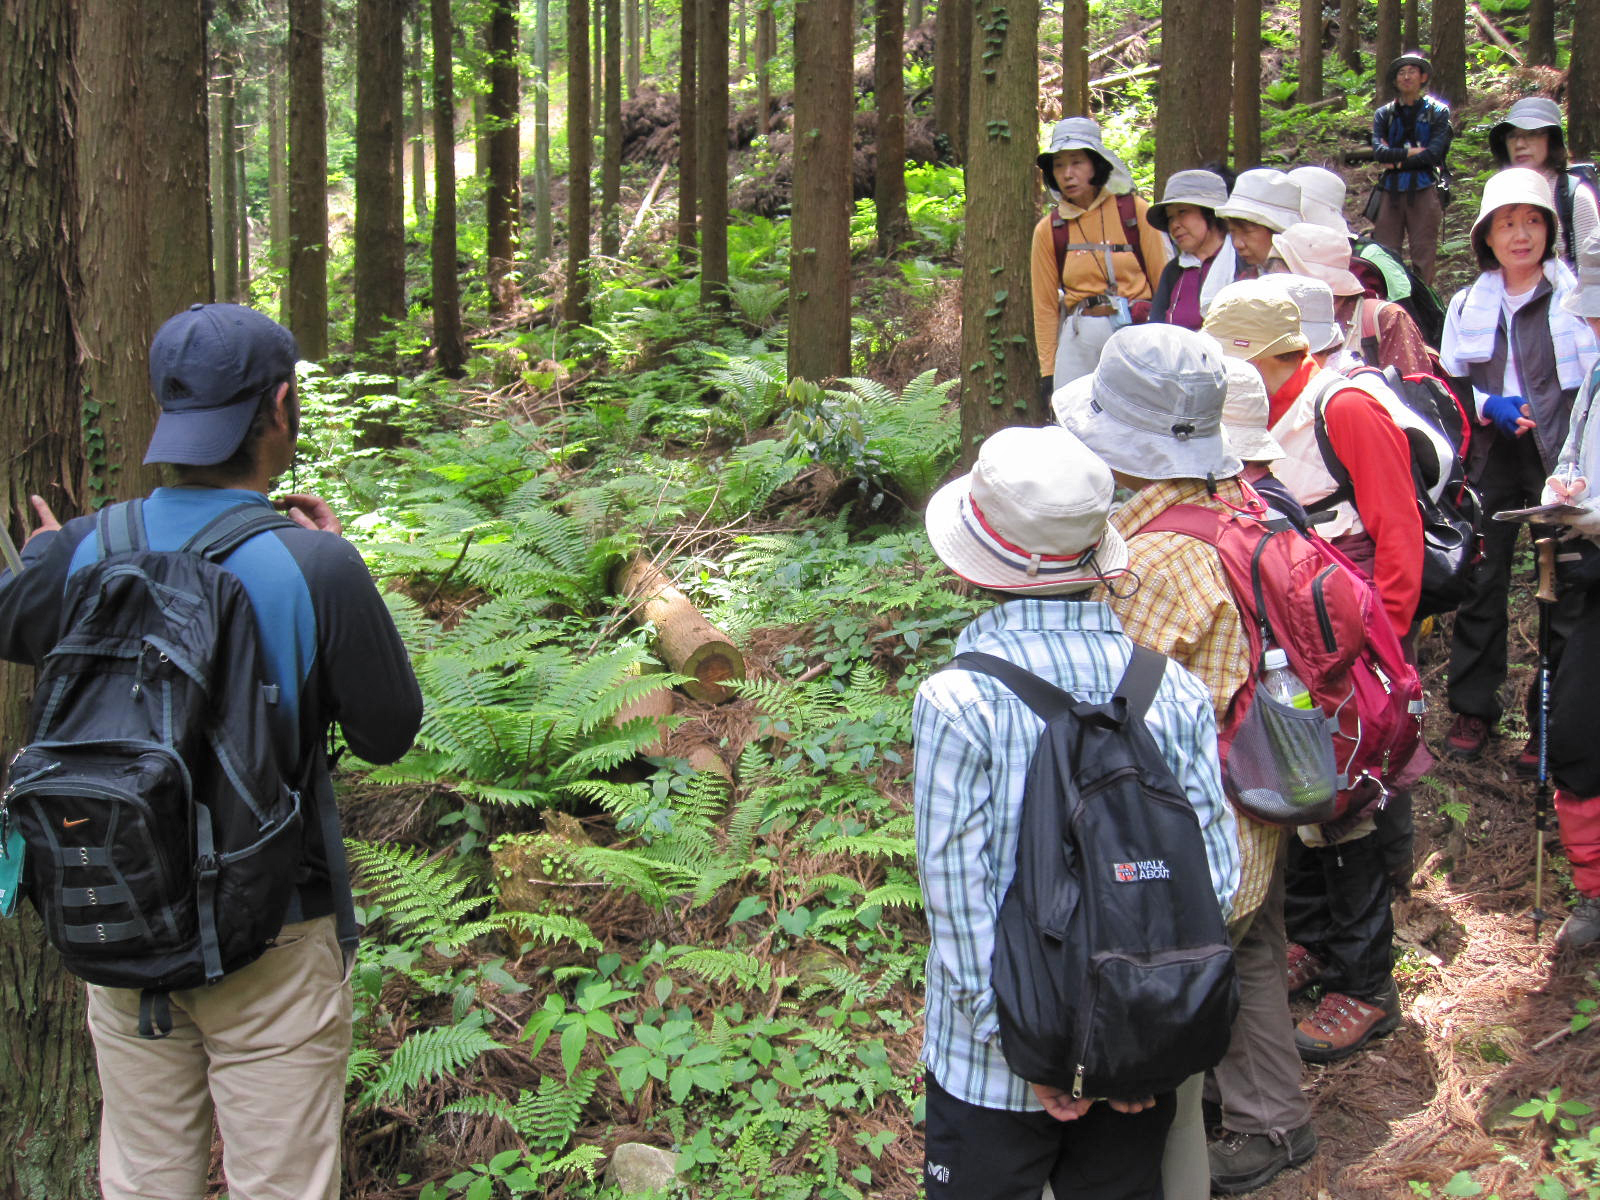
[912,598,1238,1110]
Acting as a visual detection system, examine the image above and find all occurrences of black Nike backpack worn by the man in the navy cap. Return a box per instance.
[0,501,337,1037]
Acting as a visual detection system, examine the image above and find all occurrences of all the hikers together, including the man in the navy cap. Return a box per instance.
[0,35,1600,1200]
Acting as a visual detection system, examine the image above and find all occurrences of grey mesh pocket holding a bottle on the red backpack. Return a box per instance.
[1226,688,1339,826]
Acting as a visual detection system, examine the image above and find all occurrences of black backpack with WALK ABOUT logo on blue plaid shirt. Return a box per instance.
[952,646,1238,1099]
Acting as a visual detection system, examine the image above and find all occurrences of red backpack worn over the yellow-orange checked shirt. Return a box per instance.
[1139,504,1430,840]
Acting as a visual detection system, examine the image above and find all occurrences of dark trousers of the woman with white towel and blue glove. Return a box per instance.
[1446,430,1582,730]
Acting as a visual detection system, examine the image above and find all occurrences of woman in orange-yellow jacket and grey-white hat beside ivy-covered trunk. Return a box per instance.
[1030,117,1166,400]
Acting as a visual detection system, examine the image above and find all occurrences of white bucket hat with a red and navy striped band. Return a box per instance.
[923,426,1128,595]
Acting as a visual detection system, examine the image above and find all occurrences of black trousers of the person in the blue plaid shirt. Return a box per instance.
[923,1075,1174,1200]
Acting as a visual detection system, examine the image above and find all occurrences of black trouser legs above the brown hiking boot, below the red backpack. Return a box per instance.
[1283,810,1395,1000]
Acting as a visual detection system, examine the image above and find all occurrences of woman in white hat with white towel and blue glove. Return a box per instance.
[1438,166,1600,770]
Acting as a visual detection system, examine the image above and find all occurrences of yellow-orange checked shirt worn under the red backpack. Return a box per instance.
[1101,478,1283,923]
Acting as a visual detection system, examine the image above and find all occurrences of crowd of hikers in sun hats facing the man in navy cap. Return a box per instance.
[914,51,1600,1200]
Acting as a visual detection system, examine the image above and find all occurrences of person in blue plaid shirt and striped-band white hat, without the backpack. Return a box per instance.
[912,427,1238,1200]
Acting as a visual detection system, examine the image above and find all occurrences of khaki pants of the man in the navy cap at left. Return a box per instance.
[90,917,350,1200]
